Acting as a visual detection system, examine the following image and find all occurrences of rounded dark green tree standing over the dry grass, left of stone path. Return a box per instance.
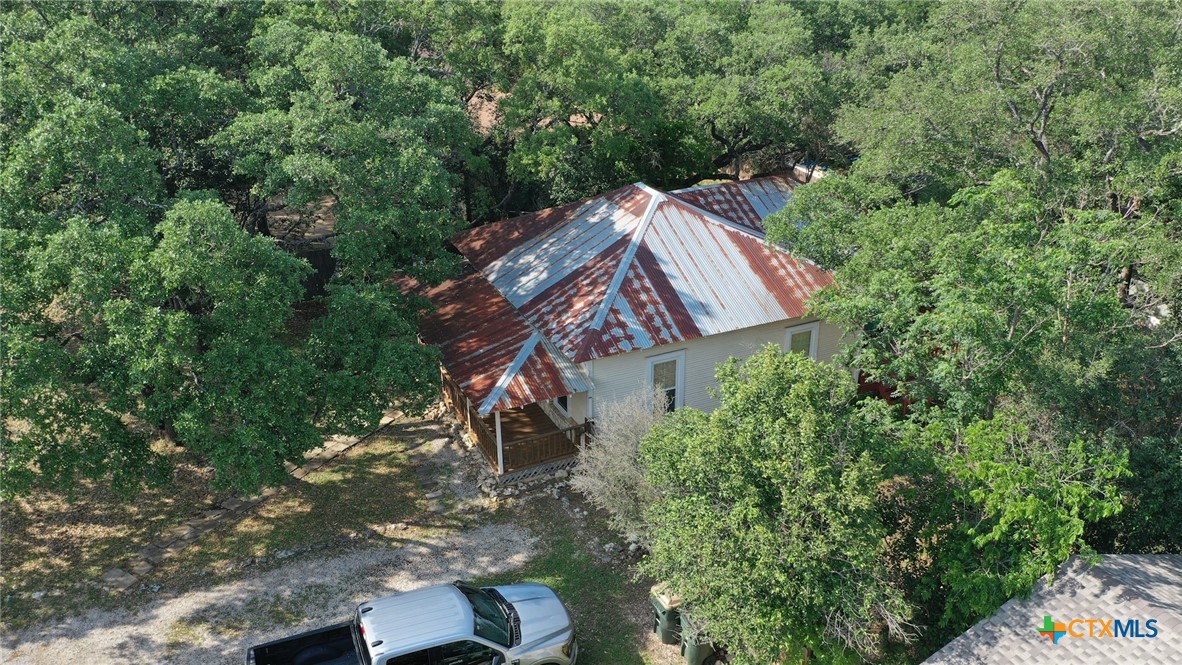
[121,194,320,490]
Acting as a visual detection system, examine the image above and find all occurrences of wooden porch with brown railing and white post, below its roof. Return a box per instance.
[443,372,592,475]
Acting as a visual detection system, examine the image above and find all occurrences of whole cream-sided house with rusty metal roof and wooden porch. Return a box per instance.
[406,168,840,474]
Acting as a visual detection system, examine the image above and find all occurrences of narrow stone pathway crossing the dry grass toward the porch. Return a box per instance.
[92,411,398,592]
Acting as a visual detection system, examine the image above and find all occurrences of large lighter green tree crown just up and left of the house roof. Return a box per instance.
[213,13,470,282]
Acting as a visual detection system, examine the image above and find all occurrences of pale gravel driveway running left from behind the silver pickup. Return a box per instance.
[2,526,535,665]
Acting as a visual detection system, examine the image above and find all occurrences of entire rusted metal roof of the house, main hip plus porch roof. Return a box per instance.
[422,177,832,413]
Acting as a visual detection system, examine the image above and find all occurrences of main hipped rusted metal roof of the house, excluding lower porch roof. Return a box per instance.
[456,177,831,363]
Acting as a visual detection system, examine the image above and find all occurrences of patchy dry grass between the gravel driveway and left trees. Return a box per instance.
[0,432,422,631]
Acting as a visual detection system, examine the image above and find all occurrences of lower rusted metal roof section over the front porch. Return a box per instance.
[400,267,591,413]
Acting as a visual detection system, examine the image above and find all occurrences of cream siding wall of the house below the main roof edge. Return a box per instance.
[586,317,842,422]
